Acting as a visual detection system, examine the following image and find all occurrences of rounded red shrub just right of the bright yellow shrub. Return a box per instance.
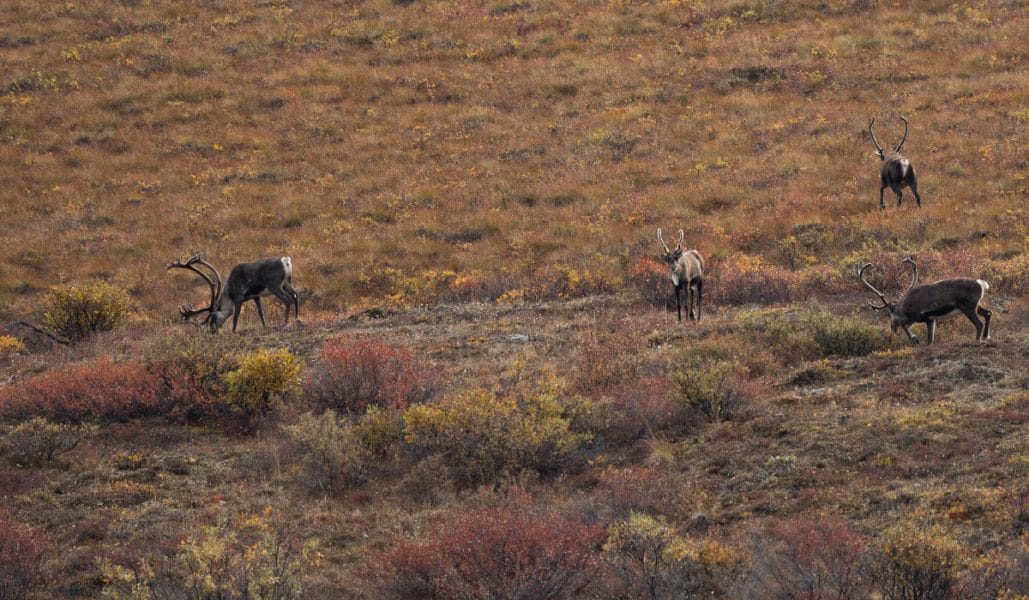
[304,340,445,414]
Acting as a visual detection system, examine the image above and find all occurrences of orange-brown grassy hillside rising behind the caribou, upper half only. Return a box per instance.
[0,0,1026,318]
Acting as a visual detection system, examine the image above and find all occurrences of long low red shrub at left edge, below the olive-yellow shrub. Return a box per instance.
[0,358,165,422]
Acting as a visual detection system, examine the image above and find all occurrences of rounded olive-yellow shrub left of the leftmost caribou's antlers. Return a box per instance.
[43,280,131,342]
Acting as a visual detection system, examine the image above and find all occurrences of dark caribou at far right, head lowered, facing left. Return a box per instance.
[857,256,992,344]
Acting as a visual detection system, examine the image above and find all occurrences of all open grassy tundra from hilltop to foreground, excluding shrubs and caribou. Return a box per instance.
[0,0,1029,596]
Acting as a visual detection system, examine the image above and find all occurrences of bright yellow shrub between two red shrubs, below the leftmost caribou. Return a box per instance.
[216,348,301,430]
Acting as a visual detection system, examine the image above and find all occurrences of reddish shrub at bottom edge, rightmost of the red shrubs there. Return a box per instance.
[748,516,868,600]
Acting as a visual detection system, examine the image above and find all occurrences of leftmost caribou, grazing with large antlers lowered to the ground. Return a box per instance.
[168,252,300,333]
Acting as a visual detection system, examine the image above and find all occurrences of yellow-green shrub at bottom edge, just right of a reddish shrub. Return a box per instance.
[867,522,962,600]
